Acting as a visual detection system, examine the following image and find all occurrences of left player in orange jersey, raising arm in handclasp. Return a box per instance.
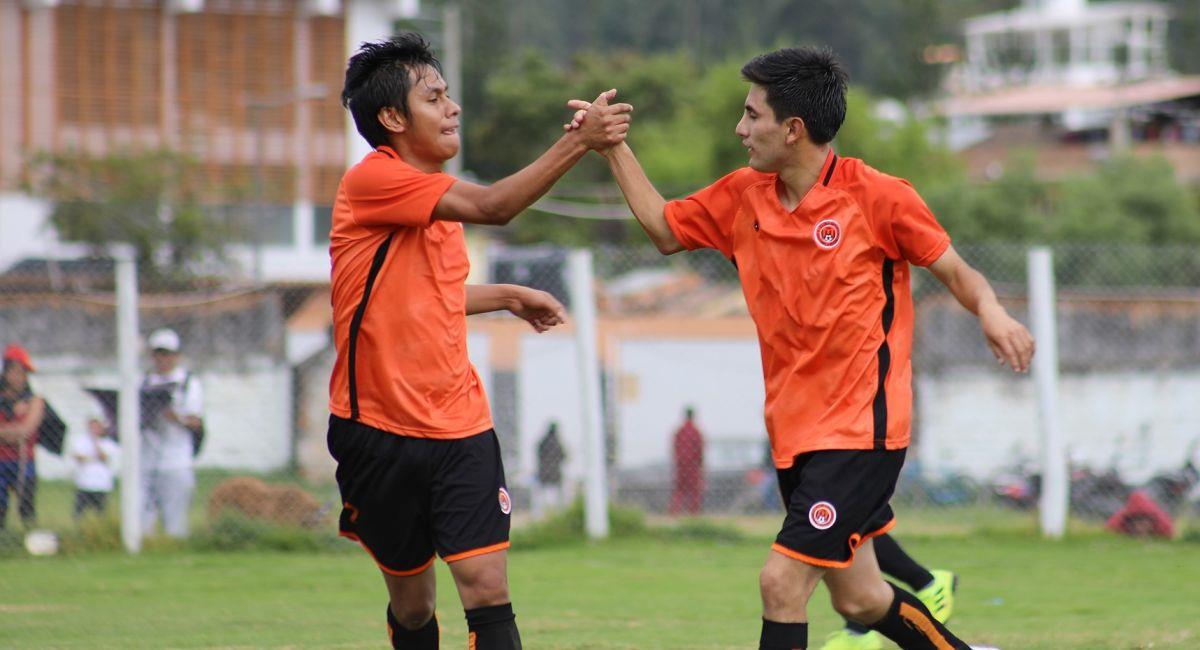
[329,34,631,650]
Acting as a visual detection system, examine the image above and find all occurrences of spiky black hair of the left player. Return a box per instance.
[342,32,442,146]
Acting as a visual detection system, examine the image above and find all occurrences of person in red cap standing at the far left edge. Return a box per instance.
[0,344,46,529]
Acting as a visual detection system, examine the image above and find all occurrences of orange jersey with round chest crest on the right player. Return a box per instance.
[666,151,950,468]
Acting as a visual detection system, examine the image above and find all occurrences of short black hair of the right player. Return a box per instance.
[742,47,847,144]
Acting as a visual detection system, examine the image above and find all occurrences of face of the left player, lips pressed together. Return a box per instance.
[403,67,462,163]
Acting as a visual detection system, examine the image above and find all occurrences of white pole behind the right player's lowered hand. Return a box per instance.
[1028,246,1070,540]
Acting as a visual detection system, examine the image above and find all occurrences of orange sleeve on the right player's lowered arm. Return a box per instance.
[875,179,950,266]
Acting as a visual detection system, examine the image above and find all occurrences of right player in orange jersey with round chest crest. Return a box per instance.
[564,48,1033,650]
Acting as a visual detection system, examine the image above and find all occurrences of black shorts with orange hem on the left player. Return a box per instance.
[328,416,512,576]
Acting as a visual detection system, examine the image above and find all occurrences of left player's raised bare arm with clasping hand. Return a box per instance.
[433,90,634,225]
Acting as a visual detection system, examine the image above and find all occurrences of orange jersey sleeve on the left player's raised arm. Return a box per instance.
[343,158,457,227]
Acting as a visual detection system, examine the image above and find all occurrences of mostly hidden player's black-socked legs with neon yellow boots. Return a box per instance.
[821,532,959,650]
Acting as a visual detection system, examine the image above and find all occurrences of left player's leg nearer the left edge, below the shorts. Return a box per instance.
[380,562,440,650]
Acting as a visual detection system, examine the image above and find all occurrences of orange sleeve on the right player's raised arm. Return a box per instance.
[664,169,754,257]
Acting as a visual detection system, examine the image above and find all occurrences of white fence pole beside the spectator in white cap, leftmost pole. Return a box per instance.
[113,246,142,553]
